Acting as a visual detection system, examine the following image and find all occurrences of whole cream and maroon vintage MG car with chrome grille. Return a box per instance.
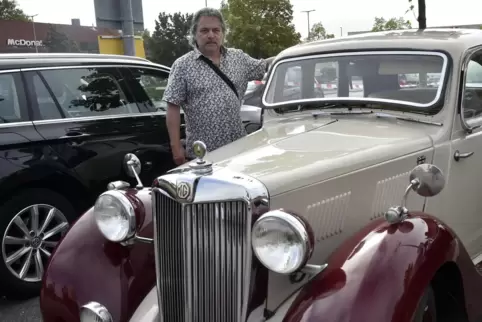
[40,29,482,322]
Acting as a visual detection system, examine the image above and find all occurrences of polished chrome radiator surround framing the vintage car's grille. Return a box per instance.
[152,169,269,322]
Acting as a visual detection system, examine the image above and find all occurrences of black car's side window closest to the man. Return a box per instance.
[129,68,169,112]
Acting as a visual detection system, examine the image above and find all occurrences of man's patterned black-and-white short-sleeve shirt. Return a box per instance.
[163,47,266,158]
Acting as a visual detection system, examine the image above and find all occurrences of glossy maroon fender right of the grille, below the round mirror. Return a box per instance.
[283,213,482,322]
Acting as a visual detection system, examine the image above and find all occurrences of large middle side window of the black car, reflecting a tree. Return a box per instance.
[33,67,140,120]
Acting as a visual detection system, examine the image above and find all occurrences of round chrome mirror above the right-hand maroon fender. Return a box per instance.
[410,164,445,197]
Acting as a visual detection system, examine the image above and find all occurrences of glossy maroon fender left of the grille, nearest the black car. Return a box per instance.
[40,189,156,322]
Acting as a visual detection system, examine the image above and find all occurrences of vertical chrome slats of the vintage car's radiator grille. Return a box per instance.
[153,191,251,322]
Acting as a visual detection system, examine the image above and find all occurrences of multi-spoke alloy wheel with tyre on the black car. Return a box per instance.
[0,189,76,300]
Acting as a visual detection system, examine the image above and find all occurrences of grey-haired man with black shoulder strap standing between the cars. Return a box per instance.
[163,8,267,165]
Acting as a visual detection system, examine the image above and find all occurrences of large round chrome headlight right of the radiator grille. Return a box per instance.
[251,210,313,274]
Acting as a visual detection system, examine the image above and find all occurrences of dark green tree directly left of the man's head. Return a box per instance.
[149,12,193,66]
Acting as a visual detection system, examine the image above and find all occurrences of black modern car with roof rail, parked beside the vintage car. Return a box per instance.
[0,54,261,298]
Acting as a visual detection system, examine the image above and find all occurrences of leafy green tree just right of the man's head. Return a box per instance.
[221,0,301,58]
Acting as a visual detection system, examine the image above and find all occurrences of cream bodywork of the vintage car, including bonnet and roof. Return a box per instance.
[131,30,482,321]
